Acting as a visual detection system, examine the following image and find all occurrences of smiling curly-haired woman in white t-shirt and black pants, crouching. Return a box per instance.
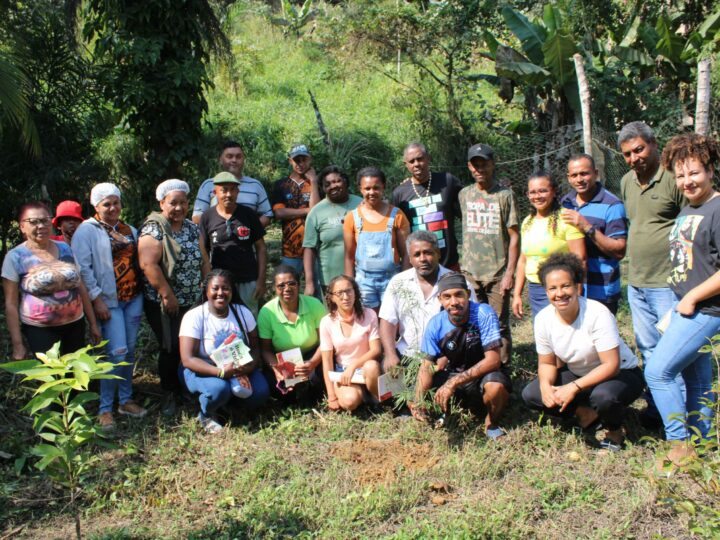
[522,253,644,451]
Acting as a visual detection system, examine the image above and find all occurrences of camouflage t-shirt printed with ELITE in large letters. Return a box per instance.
[460,183,518,282]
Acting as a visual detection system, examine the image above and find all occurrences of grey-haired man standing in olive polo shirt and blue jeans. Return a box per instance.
[618,122,685,421]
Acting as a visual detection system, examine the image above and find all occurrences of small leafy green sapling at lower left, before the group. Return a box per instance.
[0,342,119,538]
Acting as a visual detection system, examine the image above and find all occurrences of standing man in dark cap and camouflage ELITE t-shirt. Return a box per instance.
[460,144,520,365]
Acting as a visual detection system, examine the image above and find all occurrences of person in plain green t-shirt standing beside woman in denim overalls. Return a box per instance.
[303,165,362,298]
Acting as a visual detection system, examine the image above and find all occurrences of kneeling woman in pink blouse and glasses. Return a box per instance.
[320,275,382,411]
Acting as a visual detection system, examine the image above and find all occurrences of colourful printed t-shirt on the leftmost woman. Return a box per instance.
[2,242,83,326]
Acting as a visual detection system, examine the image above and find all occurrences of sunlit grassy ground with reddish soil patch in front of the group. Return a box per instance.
[0,229,704,539]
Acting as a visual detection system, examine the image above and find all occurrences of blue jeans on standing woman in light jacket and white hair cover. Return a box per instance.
[98,294,143,414]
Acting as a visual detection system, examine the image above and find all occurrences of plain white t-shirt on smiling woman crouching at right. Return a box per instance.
[534,297,638,377]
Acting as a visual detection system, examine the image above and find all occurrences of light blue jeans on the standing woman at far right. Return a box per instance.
[645,311,720,441]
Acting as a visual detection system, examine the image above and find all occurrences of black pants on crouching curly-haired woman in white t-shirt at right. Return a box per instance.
[522,368,645,430]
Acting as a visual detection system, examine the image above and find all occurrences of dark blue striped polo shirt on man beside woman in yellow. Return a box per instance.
[560,182,628,302]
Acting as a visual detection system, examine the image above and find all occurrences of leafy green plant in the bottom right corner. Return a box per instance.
[657,334,720,538]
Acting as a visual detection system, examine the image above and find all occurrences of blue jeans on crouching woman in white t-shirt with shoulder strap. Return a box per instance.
[181,366,270,416]
